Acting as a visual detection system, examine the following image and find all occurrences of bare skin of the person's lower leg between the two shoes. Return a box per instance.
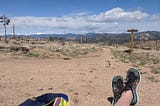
[114,90,133,106]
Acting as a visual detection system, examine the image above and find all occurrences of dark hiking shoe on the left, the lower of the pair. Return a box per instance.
[112,76,124,106]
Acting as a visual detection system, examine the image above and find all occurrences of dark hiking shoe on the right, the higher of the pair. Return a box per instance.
[125,68,140,105]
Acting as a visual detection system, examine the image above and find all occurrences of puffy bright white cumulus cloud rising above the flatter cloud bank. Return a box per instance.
[89,7,148,22]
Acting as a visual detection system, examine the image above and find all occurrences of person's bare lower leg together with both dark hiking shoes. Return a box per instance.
[112,68,140,106]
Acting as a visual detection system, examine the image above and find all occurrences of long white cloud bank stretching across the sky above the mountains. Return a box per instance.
[0,7,160,33]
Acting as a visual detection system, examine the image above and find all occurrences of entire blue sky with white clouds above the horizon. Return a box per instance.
[0,0,160,34]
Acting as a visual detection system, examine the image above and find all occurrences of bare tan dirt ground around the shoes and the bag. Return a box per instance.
[0,47,160,106]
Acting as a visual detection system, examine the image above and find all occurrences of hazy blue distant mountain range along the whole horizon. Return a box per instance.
[5,31,160,43]
